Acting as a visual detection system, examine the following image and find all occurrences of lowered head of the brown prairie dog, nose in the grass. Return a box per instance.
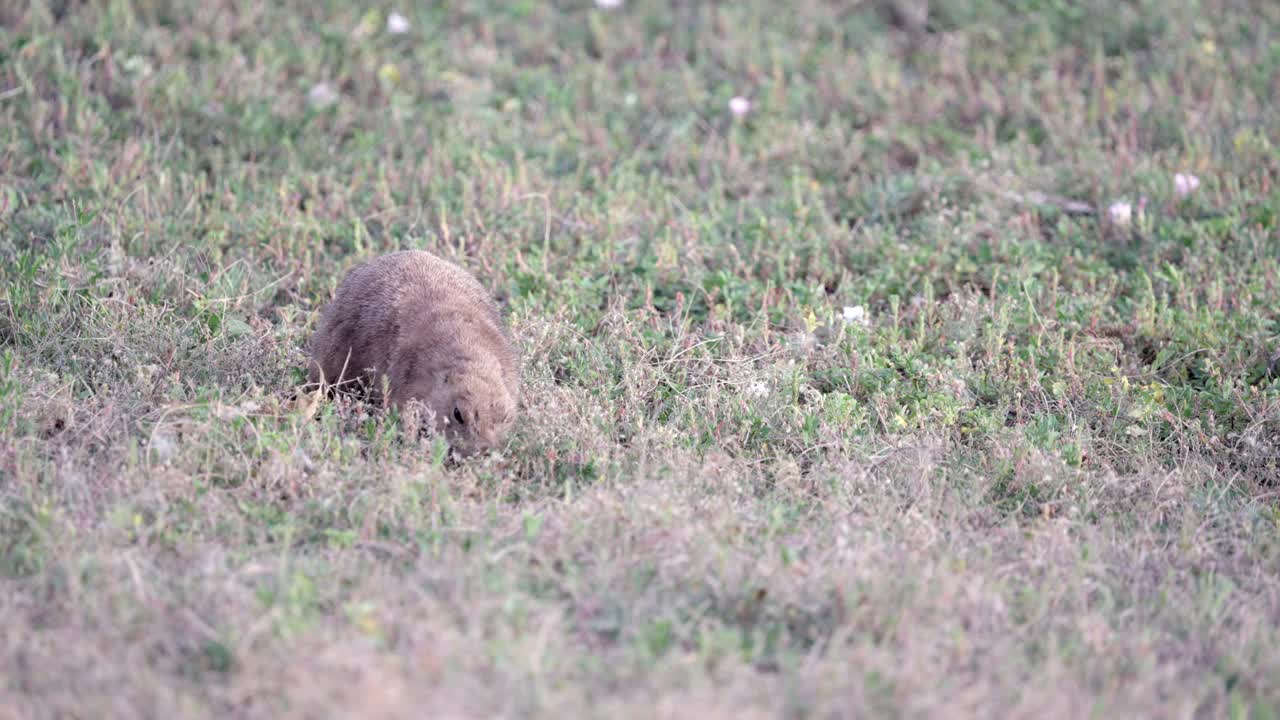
[403,363,516,456]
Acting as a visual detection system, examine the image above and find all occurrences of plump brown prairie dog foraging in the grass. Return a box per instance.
[310,250,518,455]
